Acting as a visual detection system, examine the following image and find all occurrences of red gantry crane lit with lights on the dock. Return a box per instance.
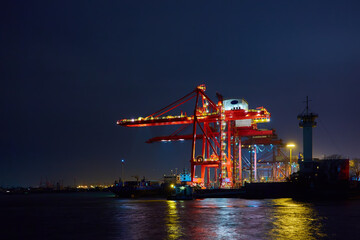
[117,84,282,188]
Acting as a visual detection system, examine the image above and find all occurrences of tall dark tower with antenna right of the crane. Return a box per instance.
[298,97,318,173]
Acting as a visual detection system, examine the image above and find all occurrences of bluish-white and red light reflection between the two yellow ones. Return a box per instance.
[188,198,270,239]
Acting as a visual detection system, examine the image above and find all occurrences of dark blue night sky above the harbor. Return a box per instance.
[0,0,360,186]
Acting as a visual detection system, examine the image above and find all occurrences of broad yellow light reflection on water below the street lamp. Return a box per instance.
[269,198,326,240]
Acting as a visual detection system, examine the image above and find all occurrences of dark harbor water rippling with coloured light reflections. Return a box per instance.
[0,193,360,240]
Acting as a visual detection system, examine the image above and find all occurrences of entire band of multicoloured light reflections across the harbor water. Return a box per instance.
[114,198,327,240]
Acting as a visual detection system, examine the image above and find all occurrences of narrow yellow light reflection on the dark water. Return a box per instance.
[165,201,182,239]
